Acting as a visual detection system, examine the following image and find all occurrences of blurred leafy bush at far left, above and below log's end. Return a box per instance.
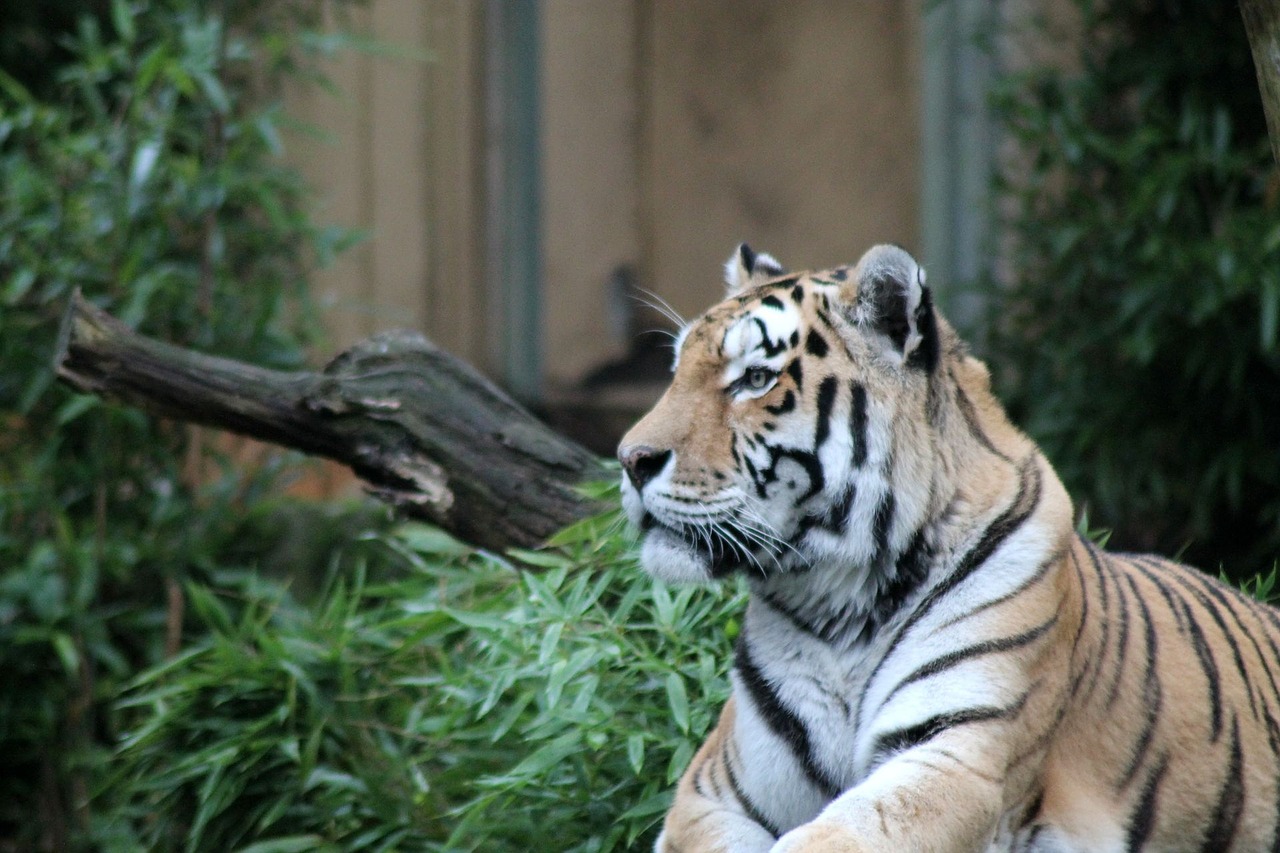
[0,0,360,849]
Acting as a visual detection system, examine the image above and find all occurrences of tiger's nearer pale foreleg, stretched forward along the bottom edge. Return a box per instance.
[771,733,1006,853]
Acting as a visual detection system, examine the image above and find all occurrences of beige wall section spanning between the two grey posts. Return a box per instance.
[543,0,919,382]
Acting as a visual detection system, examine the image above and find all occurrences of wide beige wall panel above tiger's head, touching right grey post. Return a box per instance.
[644,0,918,322]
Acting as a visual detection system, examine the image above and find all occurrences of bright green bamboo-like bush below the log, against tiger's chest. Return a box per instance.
[104,519,744,853]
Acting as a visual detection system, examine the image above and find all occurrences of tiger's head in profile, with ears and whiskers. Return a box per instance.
[618,243,986,581]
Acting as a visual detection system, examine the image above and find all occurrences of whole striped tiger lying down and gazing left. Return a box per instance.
[618,243,1280,853]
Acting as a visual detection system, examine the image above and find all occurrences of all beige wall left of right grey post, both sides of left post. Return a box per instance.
[289,0,918,389]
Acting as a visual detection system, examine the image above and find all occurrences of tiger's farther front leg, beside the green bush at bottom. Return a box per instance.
[654,698,778,853]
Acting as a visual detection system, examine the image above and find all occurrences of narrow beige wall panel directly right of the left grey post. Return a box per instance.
[541,0,641,387]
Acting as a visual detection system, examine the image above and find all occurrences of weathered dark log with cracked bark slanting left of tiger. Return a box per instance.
[55,293,613,549]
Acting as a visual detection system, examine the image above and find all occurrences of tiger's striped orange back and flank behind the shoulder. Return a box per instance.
[1028,540,1280,850]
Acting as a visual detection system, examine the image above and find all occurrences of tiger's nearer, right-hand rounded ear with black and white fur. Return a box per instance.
[841,245,938,371]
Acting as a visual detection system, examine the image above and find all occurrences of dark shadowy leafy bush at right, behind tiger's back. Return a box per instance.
[991,0,1280,578]
